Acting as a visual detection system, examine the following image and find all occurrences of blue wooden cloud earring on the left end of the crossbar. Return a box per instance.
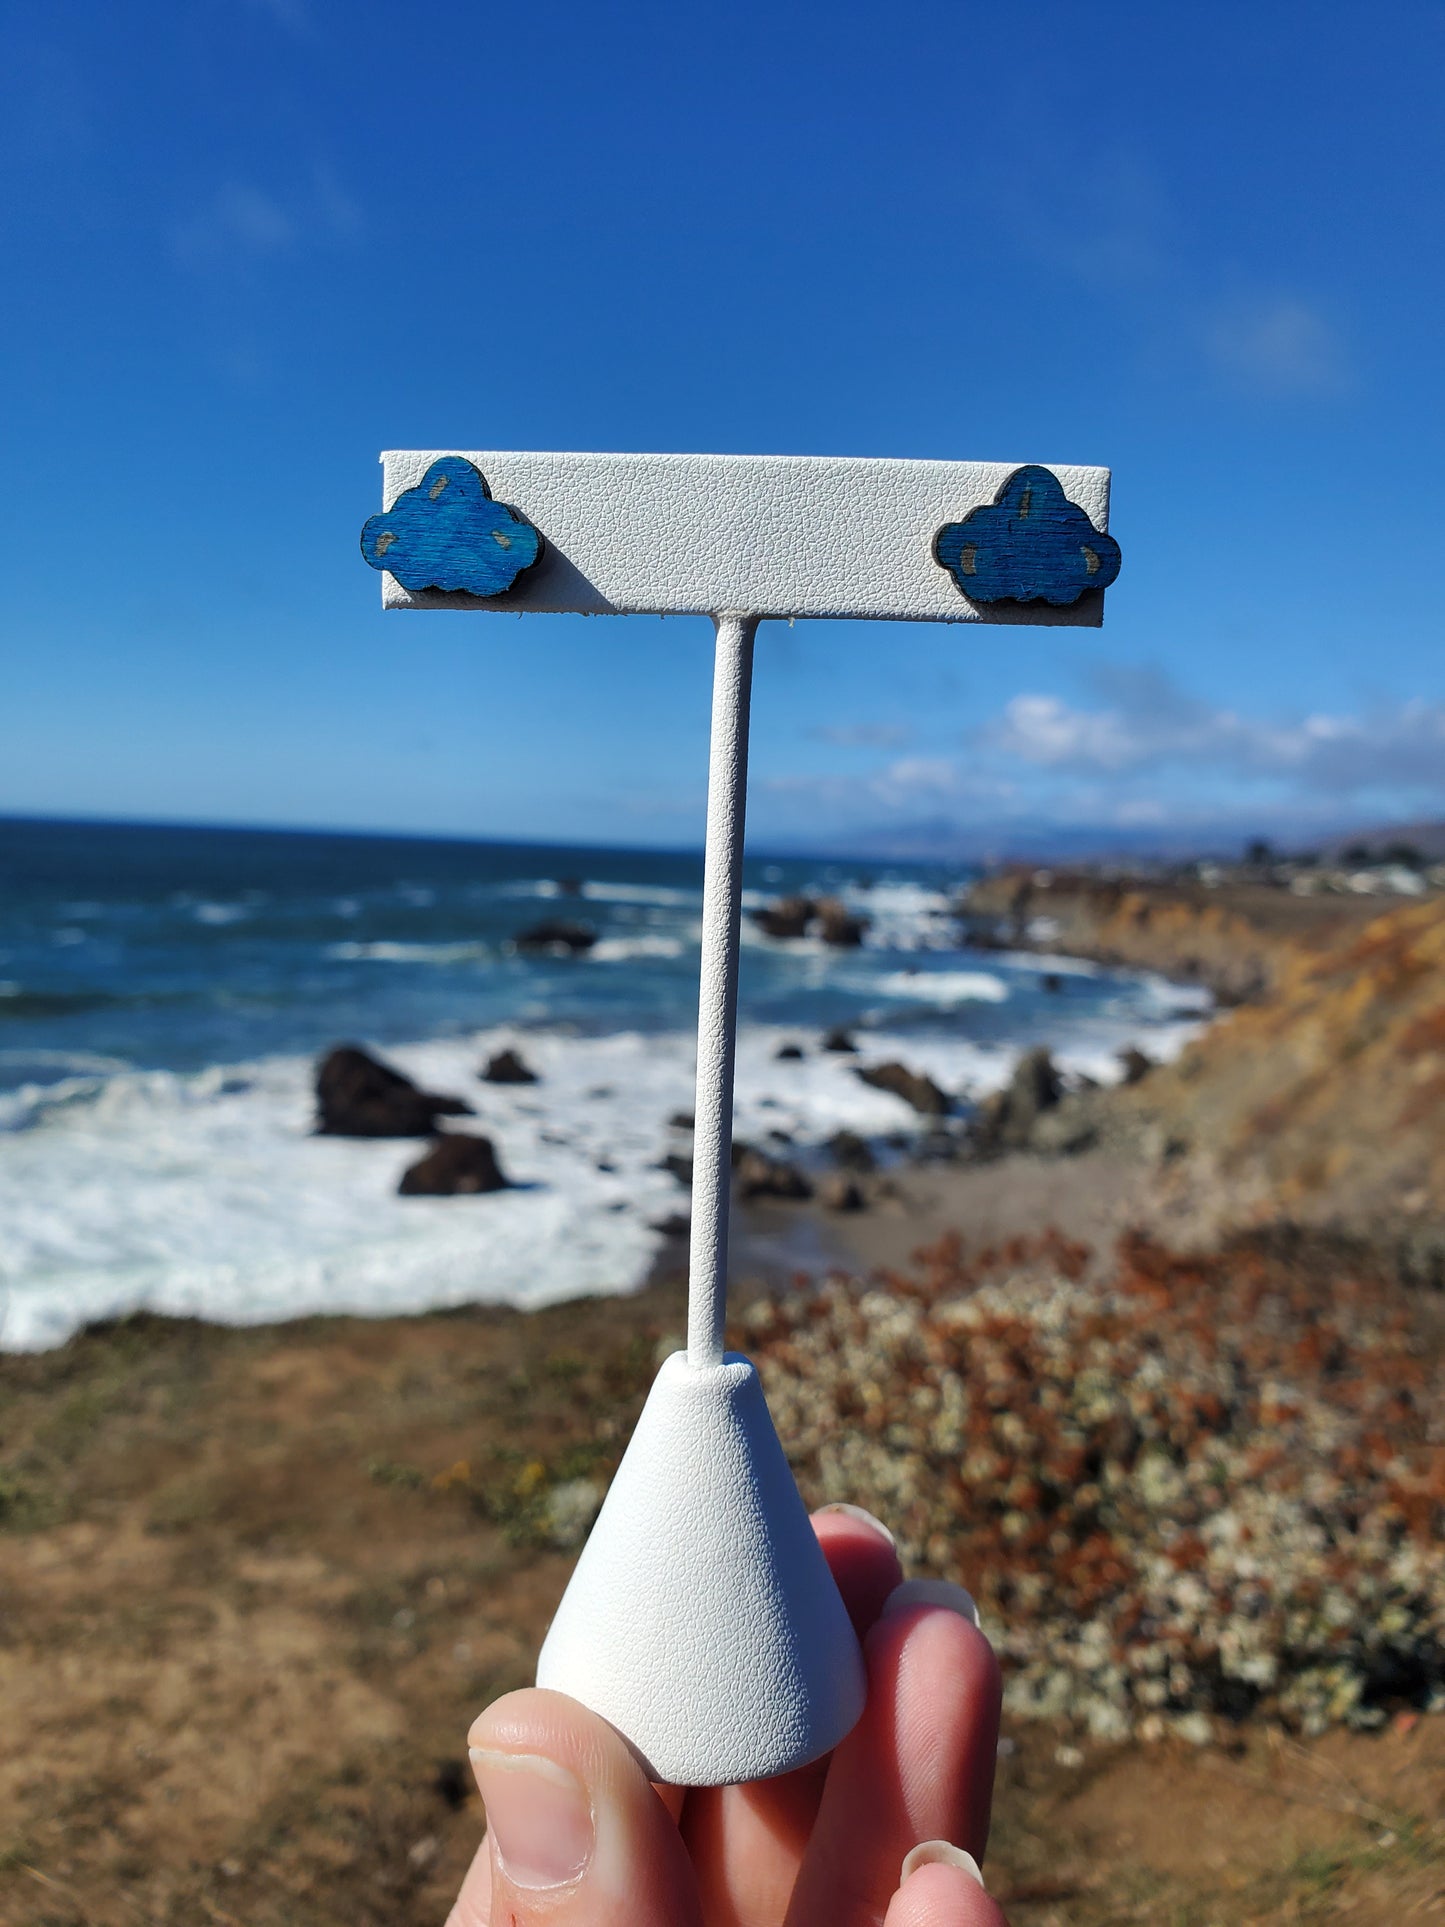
[362,455,541,595]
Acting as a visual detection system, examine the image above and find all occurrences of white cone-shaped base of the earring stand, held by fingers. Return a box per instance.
[538,1353,865,1786]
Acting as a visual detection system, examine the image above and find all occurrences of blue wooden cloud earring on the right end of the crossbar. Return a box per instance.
[933,464,1119,607]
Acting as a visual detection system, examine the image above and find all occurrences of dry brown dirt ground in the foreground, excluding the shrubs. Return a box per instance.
[0,1256,1445,1927]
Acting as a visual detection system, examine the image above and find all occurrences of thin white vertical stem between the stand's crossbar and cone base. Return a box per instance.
[688,615,757,1370]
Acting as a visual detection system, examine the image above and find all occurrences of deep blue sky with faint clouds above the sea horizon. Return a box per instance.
[0,0,1445,859]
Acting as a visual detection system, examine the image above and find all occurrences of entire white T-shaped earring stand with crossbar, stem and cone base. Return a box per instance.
[362,453,1117,1786]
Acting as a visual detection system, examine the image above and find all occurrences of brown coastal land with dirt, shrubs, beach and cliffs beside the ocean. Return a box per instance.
[0,884,1445,1927]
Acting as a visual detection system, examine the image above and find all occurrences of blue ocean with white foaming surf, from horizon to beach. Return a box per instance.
[0,821,1206,1351]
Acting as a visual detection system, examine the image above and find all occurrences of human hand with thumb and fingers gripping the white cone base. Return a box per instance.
[447,1507,1008,1927]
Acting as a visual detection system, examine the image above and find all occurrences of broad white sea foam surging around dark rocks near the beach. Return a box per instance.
[0,1025,1156,1351]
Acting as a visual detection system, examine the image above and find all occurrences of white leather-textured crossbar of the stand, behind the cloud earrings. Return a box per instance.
[381,449,1110,628]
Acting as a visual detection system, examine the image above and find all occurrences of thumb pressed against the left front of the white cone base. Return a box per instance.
[454,1688,701,1927]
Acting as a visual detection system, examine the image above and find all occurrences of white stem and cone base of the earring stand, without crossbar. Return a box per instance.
[538,615,863,1786]
